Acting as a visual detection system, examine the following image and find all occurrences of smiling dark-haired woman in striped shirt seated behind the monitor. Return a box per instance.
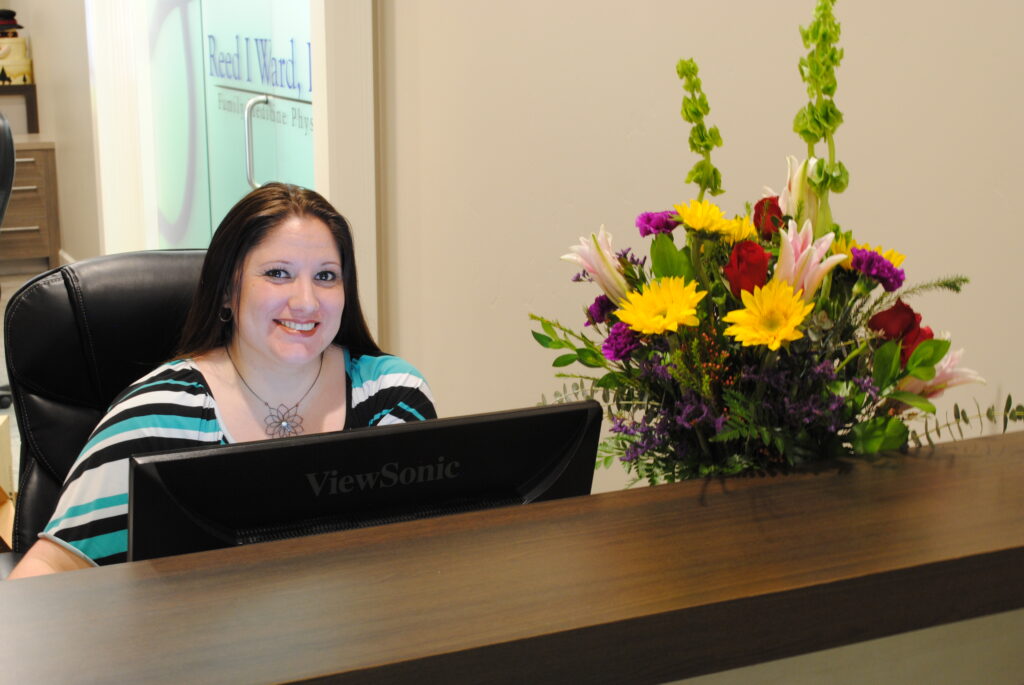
[10,183,436,579]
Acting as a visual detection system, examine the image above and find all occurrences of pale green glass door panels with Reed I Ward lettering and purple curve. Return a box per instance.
[150,0,313,248]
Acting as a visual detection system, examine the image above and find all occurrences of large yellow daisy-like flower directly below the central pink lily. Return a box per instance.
[722,281,814,350]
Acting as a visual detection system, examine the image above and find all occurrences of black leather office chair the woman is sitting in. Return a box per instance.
[0,245,206,577]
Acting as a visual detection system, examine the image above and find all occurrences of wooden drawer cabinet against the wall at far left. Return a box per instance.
[0,135,60,268]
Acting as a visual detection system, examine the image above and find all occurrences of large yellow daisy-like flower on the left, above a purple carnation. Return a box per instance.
[614,276,708,335]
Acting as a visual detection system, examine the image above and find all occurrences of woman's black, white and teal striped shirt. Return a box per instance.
[39,349,437,564]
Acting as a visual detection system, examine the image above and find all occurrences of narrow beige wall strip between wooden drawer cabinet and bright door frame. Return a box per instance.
[6,0,102,259]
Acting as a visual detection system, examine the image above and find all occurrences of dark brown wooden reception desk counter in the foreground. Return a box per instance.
[6,433,1024,683]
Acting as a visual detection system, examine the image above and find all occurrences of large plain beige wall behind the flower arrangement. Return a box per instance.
[377,0,1024,438]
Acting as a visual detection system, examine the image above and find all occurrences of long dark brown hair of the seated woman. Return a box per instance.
[177,183,381,358]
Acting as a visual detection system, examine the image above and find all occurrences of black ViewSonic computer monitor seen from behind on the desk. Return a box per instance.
[128,400,601,560]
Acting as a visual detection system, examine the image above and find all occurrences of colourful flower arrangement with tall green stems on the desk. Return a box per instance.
[531,0,1024,482]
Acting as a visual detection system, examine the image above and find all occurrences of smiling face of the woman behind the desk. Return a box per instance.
[232,216,345,365]
